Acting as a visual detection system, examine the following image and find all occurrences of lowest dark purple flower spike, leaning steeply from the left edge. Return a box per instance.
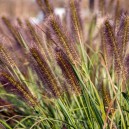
[0,72,37,106]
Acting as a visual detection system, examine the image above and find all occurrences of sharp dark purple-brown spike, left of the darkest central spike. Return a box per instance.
[30,48,60,97]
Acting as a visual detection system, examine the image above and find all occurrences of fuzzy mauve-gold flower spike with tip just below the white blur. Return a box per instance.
[46,15,80,64]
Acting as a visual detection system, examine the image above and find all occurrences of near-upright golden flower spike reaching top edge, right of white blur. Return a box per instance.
[70,0,82,43]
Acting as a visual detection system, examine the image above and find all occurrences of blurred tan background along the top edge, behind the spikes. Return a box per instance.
[0,0,129,18]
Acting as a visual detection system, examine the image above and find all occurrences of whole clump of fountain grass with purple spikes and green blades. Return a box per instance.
[0,0,129,129]
